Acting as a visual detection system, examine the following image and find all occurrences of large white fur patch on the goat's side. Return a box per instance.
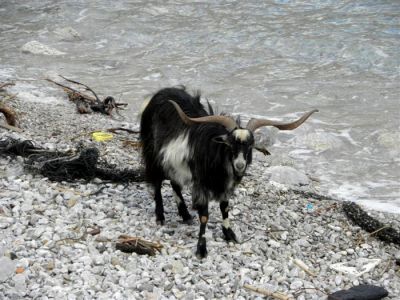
[160,133,192,186]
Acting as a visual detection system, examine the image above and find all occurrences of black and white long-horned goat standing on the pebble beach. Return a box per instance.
[140,88,316,258]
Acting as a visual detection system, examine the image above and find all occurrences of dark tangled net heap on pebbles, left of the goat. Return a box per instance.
[0,137,144,182]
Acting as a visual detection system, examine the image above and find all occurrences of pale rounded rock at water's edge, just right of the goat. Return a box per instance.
[266,166,310,186]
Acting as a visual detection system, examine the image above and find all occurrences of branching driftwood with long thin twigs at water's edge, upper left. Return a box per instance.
[46,75,128,115]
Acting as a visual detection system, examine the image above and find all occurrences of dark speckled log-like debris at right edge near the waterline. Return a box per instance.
[342,202,400,245]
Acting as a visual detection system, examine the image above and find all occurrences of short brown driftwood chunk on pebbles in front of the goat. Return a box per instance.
[115,235,163,256]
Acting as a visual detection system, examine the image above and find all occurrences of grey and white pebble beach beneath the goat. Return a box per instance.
[0,90,400,299]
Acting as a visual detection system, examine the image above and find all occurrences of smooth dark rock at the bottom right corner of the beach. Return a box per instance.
[328,284,389,300]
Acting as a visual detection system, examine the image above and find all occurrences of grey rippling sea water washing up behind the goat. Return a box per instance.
[0,0,400,213]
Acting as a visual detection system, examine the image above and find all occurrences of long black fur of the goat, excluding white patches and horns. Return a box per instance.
[140,88,254,257]
